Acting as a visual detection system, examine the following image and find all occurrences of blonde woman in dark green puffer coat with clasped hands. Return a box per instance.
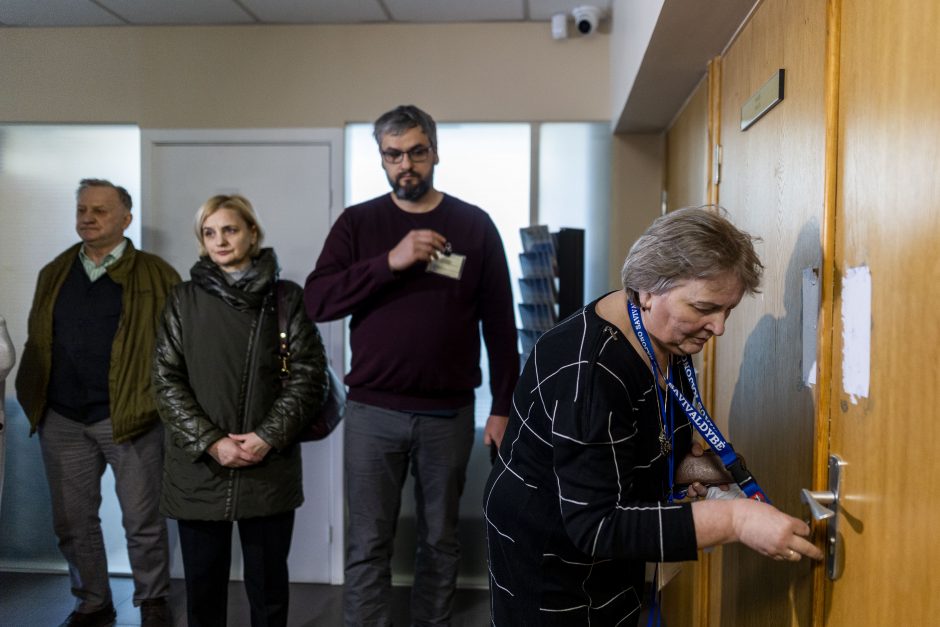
[153,195,327,627]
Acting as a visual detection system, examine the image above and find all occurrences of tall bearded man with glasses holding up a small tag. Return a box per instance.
[305,105,519,625]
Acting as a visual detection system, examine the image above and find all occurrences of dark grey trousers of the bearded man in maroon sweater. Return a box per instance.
[343,401,474,627]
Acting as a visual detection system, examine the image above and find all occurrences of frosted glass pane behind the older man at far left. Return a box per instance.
[0,124,143,573]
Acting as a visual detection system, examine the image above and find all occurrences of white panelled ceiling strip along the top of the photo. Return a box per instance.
[0,0,611,27]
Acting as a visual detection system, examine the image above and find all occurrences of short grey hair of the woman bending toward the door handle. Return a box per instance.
[620,206,764,305]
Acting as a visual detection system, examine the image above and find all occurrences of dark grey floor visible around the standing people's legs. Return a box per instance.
[0,571,490,627]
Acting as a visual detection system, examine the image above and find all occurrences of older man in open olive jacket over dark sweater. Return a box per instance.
[16,179,180,627]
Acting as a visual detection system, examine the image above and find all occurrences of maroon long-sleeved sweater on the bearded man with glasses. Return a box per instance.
[304,194,519,416]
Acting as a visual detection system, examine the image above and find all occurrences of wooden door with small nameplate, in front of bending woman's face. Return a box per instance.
[707,0,826,627]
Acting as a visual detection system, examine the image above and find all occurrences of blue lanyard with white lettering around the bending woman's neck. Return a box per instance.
[627,298,770,503]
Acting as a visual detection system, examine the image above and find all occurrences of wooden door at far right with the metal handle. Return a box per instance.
[823,0,940,627]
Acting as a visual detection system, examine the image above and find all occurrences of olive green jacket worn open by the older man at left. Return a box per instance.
[16,241,180,442]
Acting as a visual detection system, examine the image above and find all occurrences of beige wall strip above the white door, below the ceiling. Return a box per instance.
[0,23,611,128]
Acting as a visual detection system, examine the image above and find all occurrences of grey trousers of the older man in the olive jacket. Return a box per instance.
[39,410,170,613]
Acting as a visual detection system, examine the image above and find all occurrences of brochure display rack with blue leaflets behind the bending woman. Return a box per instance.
[519,225,584,363]
